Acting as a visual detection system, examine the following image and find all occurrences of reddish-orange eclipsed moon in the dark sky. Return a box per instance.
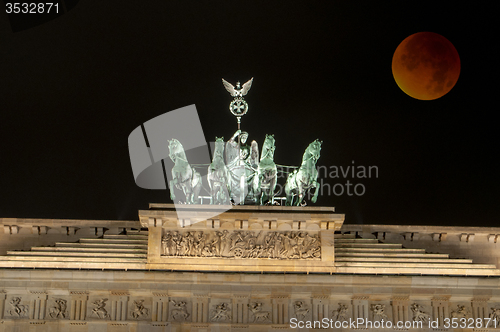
[392,32,460,100]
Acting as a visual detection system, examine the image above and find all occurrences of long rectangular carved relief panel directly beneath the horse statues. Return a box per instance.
[162,230,321,259]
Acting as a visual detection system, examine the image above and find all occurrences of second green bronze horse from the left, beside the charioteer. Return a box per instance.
[207,137,230,204]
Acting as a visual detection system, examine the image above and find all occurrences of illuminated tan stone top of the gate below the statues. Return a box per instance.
[0,204,500,332]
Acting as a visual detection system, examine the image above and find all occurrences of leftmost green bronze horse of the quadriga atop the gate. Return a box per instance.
[168,138,201,204]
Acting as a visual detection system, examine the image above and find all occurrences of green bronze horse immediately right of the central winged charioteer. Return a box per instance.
[253,135,278,205]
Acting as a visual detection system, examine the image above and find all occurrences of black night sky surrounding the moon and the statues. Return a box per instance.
[0,0,500,226]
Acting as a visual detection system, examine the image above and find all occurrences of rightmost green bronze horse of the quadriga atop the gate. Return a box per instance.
[285,140,323,206]
